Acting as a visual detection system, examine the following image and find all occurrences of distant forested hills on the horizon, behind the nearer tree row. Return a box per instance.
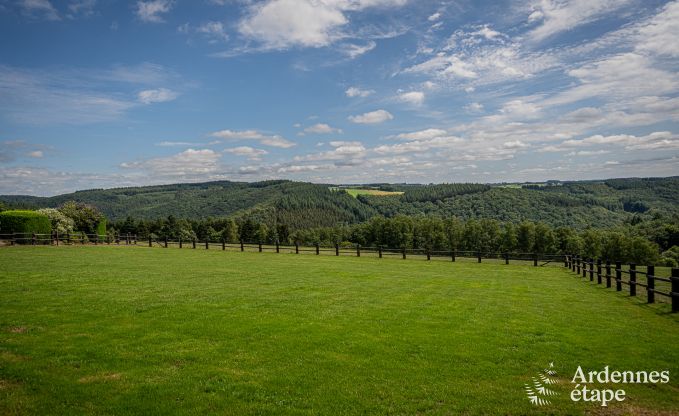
[0,177,679,229]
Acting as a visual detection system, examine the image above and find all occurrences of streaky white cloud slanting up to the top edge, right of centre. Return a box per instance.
[528,0,632,42]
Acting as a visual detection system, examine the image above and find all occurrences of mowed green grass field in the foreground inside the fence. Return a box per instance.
[0,246,679,415]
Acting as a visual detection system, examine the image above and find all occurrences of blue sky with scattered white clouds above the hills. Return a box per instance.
[0,0,679,196]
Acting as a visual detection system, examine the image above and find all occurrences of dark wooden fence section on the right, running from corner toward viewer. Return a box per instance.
[565,254,679,312]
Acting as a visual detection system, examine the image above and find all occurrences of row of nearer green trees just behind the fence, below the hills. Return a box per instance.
[110,215,679,266]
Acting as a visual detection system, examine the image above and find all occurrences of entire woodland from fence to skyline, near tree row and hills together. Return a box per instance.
[0,177,679,261]
